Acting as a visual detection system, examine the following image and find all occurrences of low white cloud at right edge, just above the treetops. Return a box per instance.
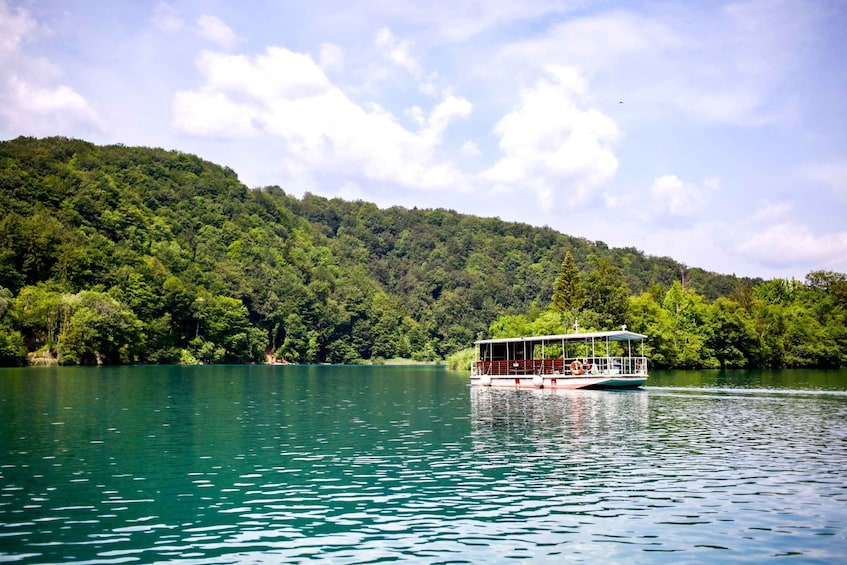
[737,202,847,270]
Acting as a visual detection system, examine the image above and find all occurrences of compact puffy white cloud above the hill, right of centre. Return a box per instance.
[482,67,619,207]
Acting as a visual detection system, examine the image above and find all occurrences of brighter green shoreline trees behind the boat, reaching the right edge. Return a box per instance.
[480,253,847,369]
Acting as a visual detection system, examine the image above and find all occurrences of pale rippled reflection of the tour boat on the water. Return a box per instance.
[470,387,649,479]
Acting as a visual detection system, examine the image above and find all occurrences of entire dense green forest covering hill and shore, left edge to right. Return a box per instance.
[0,134,847,367]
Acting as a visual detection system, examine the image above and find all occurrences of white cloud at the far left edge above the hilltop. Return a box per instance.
[0,2,102,135]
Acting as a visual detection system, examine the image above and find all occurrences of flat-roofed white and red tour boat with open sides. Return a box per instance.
[471,327,647,389]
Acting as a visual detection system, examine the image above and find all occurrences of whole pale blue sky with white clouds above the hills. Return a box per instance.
[0,0,847,280]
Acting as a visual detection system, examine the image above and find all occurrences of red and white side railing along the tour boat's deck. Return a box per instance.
[473,357,647,376]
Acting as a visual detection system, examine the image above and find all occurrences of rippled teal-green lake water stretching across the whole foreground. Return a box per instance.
[0,366,847,563]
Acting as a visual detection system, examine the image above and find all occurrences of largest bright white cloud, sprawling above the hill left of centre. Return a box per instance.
[173,47,471,189]
